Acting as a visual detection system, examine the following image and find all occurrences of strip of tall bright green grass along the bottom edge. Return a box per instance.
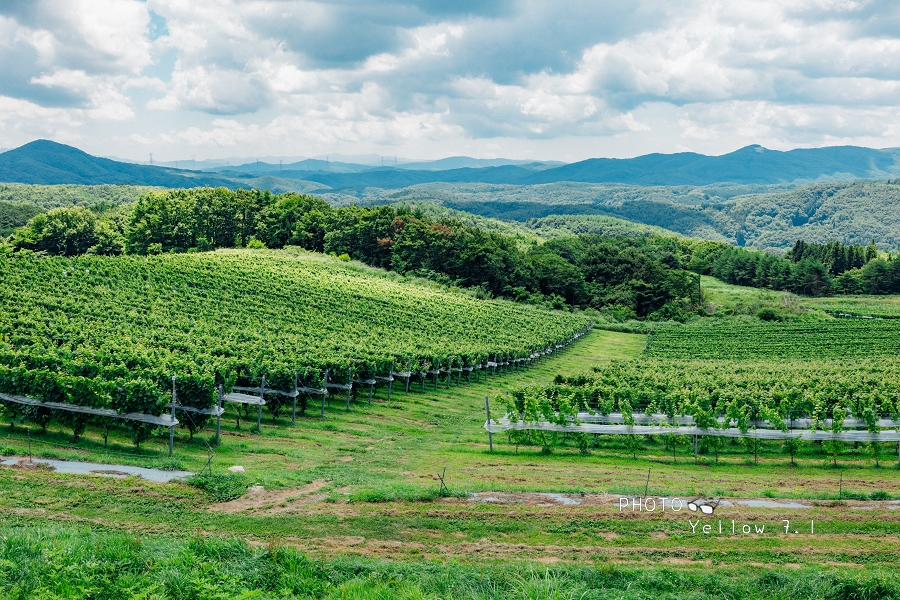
[0,524,900,600]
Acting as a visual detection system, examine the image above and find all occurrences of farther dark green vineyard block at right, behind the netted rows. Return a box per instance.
[646,318,900,360]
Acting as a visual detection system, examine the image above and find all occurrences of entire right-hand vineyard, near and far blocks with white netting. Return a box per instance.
[496,318,900,453]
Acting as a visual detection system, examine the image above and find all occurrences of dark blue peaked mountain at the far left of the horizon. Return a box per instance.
[0,140,241,188]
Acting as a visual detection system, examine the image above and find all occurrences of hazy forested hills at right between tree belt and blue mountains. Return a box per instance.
[342,180,900,252]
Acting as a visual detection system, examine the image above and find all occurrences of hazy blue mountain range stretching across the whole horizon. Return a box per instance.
[0,140,900,190]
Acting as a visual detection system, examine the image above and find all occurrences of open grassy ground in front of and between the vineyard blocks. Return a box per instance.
[0,264,900,598]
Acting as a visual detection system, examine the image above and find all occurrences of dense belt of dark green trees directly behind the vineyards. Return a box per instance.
[2,188,900,320]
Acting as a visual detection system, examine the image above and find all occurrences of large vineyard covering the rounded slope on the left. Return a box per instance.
[0,251,588,441]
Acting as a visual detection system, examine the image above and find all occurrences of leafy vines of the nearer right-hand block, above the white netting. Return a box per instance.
[508,358,900,433]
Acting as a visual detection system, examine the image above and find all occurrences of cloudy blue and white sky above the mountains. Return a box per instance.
[0,0,900,161]
